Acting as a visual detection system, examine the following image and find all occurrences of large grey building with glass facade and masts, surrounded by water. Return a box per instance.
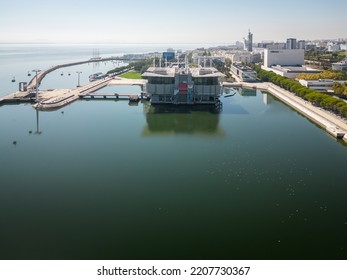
[142,67,225,105]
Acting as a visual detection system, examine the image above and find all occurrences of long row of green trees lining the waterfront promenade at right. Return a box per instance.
[254,65,347,118]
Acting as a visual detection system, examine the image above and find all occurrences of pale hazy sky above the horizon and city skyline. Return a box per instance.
[0,0,347,44]
